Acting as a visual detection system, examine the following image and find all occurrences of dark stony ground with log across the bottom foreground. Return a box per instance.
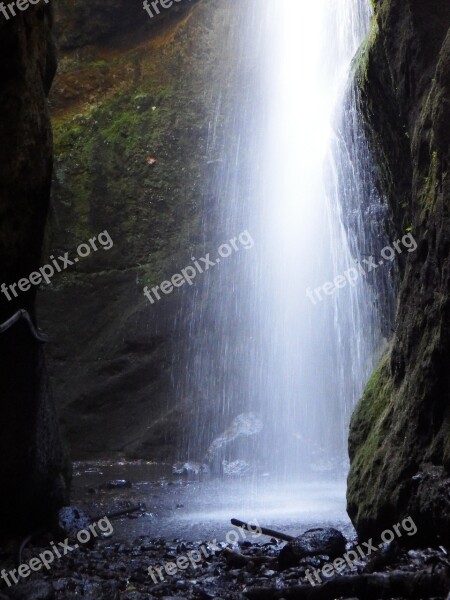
[0,516,450,600]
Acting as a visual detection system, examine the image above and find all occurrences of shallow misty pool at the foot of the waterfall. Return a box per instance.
[73,461,353,542]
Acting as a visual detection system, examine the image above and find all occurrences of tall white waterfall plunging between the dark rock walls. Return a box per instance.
[176,0,390,479]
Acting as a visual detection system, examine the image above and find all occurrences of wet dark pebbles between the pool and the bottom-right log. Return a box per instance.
[0,524,447,600]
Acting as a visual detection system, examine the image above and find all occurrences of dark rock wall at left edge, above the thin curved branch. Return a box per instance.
[0,7,56,321]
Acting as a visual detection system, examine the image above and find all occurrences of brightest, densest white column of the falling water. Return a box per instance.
[253,0,378,477]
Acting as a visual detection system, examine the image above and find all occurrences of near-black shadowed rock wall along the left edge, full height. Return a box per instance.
[0,4,67,532]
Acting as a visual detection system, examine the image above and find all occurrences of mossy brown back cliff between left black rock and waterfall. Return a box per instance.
[39,0,253,459]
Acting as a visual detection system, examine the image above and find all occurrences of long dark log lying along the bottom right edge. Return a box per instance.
[244,569,450,600]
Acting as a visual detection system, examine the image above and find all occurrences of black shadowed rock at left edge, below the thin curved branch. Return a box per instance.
[0,311,69,531]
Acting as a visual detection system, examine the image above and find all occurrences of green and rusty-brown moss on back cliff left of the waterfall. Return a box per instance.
[49,4,239,285]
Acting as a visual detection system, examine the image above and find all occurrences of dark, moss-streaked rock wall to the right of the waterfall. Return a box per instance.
[348,0,450,542]
